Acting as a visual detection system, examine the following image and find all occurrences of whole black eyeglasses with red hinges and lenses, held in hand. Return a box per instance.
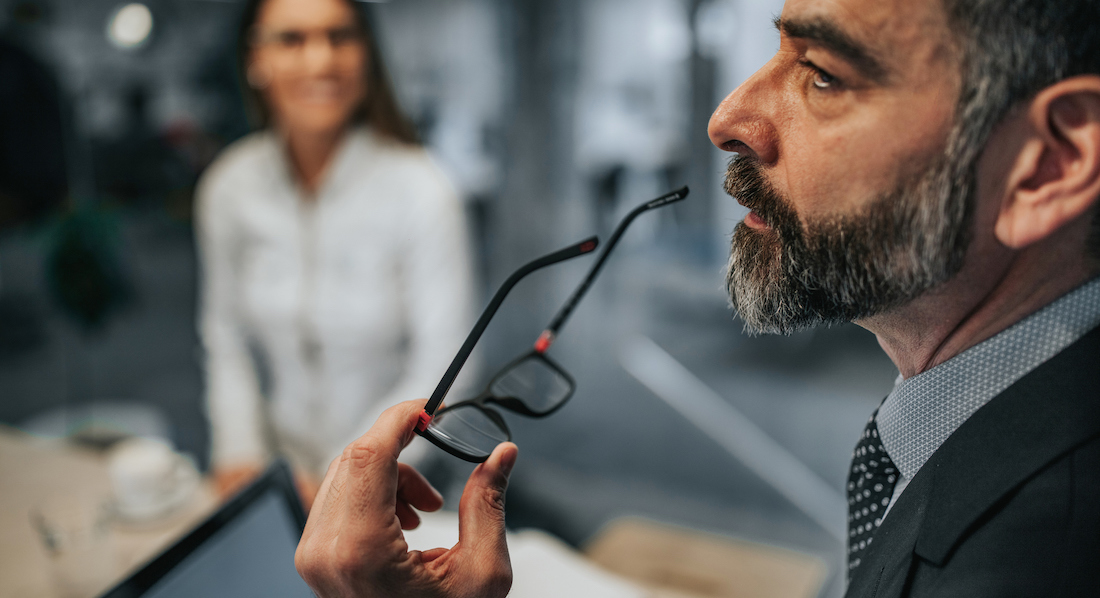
[416,187,688,463]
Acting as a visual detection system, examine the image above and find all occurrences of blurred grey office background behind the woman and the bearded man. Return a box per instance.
[0,0,897,596]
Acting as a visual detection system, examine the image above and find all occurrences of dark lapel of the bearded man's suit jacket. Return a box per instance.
[847,329,1100,597]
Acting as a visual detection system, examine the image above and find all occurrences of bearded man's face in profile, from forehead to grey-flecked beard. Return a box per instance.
[710,0,972,332]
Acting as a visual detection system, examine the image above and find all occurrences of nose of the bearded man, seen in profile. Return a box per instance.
[706,58,781,164]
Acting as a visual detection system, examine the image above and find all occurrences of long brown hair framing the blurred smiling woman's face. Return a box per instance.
[237,0,420,145]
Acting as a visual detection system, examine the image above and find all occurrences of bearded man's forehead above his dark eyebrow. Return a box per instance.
[780,0,949,66]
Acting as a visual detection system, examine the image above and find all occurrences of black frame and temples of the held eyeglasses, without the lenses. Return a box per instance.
[416,187,690,463]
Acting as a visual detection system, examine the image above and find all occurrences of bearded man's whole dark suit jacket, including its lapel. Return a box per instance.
[847,329,1100,598]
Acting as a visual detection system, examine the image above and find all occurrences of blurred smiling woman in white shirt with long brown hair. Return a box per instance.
[197,0,472,499]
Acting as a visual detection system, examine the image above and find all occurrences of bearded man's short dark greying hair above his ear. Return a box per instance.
[943,0,1100,265]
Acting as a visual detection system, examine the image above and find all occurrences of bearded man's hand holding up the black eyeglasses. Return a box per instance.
[295,400,518,598]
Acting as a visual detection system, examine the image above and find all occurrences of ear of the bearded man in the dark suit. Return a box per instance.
[994,75,1100,248]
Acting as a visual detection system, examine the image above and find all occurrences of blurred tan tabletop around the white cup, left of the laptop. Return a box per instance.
[0,425,217,598]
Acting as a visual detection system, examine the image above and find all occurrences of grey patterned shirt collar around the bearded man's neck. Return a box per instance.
[878,278,1100,478]
